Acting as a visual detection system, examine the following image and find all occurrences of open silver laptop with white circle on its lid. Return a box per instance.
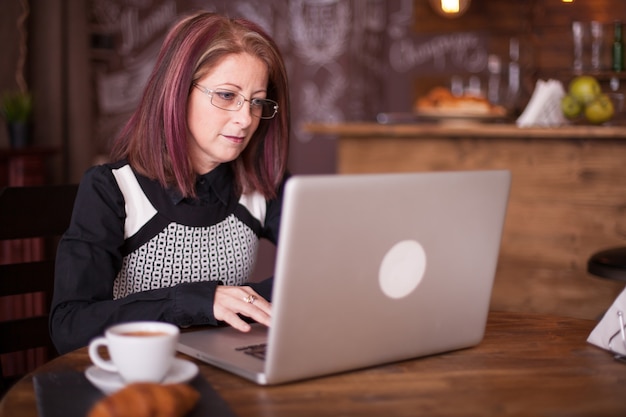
[178,170,511,385]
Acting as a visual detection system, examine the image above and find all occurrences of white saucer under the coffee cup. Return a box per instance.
[85,358,198,395]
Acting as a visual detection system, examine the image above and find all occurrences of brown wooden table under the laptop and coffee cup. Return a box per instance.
[0,312,626,417]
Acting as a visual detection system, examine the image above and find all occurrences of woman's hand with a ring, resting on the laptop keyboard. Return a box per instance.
[213,285,272,332]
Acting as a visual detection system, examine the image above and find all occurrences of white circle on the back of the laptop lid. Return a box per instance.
[378,240,426,299]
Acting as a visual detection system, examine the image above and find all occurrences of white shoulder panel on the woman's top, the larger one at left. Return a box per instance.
[113,165,157,239]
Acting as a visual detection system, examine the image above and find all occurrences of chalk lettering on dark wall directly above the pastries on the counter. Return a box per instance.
[389,33,488,73]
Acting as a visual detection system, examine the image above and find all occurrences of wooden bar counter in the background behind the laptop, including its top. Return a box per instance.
[306,123,626,318]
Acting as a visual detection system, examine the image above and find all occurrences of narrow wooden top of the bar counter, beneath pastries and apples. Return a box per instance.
[304,122,626,140]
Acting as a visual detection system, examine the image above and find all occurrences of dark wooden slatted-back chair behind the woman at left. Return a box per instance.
[0,185,78,394]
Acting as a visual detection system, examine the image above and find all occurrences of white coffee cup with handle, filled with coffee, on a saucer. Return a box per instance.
[89,321,180,383]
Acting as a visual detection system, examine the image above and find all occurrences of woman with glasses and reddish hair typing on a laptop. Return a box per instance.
[50,12,289,353]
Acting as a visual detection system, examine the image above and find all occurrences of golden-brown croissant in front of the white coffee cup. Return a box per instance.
[87,383,200,417]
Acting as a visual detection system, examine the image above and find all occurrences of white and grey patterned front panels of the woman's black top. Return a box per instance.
[113,165,266,299]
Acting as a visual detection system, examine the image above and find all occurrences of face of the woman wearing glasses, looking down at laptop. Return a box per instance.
[187,53,268,174]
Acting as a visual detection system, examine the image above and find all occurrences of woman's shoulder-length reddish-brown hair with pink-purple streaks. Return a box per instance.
[111,12,290,198]
